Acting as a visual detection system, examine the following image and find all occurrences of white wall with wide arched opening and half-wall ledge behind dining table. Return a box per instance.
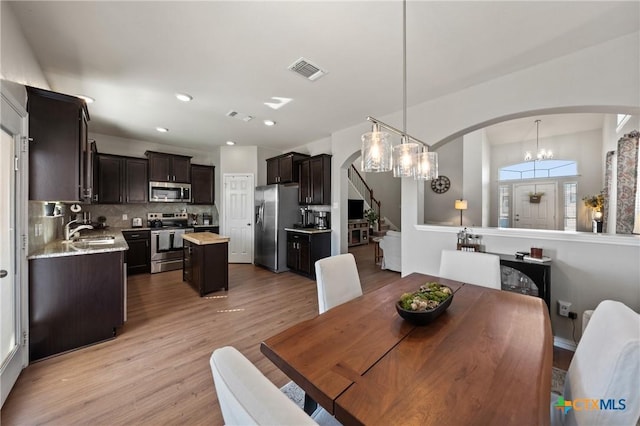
[332,32,640,339]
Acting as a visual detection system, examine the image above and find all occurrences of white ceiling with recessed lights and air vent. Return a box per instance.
[3,0,640,150]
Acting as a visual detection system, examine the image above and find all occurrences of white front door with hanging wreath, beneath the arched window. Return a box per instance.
[513,182,556,229]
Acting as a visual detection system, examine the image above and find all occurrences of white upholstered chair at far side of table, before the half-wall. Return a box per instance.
[438,250,502,290]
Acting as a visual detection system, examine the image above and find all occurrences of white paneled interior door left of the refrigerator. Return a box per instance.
[222,174,254,263]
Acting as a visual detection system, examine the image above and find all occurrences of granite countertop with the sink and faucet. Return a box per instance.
[27,228,129,260]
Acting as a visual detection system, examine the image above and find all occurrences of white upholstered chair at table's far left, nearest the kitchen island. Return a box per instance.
[315,253,362,313]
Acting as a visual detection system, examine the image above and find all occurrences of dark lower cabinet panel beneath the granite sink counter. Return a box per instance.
[29,251,125,362]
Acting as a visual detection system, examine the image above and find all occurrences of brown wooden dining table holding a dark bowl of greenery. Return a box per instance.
[260,273,553,425]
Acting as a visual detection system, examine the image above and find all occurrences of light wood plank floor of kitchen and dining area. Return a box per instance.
[0,245,563,425]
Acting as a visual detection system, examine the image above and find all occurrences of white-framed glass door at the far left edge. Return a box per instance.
[0,88,27,406]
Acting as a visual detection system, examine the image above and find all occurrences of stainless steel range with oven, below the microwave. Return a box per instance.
[147,213,193,274]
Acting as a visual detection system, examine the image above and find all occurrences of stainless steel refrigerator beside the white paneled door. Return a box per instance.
[253,184,300,272]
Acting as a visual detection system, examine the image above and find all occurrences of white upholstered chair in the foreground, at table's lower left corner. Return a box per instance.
[209,346,340,426]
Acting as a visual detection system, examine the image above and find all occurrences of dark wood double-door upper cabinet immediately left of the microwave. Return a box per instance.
[94,154,149,204]
